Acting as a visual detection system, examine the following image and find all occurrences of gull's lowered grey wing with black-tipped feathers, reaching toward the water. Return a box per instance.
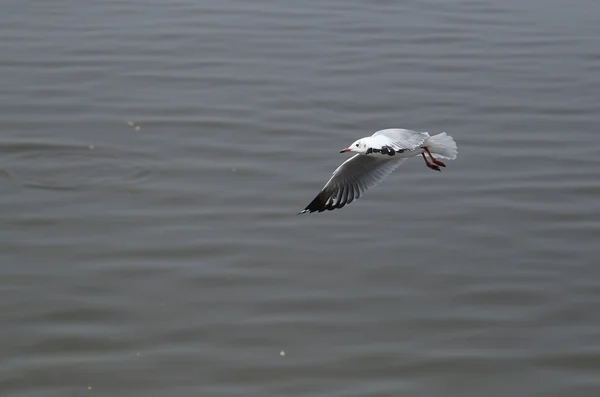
[298,154,405,215]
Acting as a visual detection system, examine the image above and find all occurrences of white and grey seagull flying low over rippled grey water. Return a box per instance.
[298,128,458,215]
